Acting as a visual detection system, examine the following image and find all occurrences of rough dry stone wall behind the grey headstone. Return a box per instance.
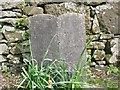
[0,0,120,69]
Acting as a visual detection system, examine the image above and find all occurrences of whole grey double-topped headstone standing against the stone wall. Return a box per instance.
[29,13,86,67]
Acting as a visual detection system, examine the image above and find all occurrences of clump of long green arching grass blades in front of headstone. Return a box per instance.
[17,35,93,90]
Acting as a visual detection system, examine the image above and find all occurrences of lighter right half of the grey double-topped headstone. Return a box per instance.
[58,13,86,67]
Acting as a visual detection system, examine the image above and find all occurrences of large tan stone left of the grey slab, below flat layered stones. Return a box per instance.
[4,31,23,42]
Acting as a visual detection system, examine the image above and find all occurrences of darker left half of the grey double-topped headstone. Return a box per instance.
[30,14,58,64]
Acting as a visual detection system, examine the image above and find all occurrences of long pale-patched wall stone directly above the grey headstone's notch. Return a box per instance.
[45,2,84,15]
